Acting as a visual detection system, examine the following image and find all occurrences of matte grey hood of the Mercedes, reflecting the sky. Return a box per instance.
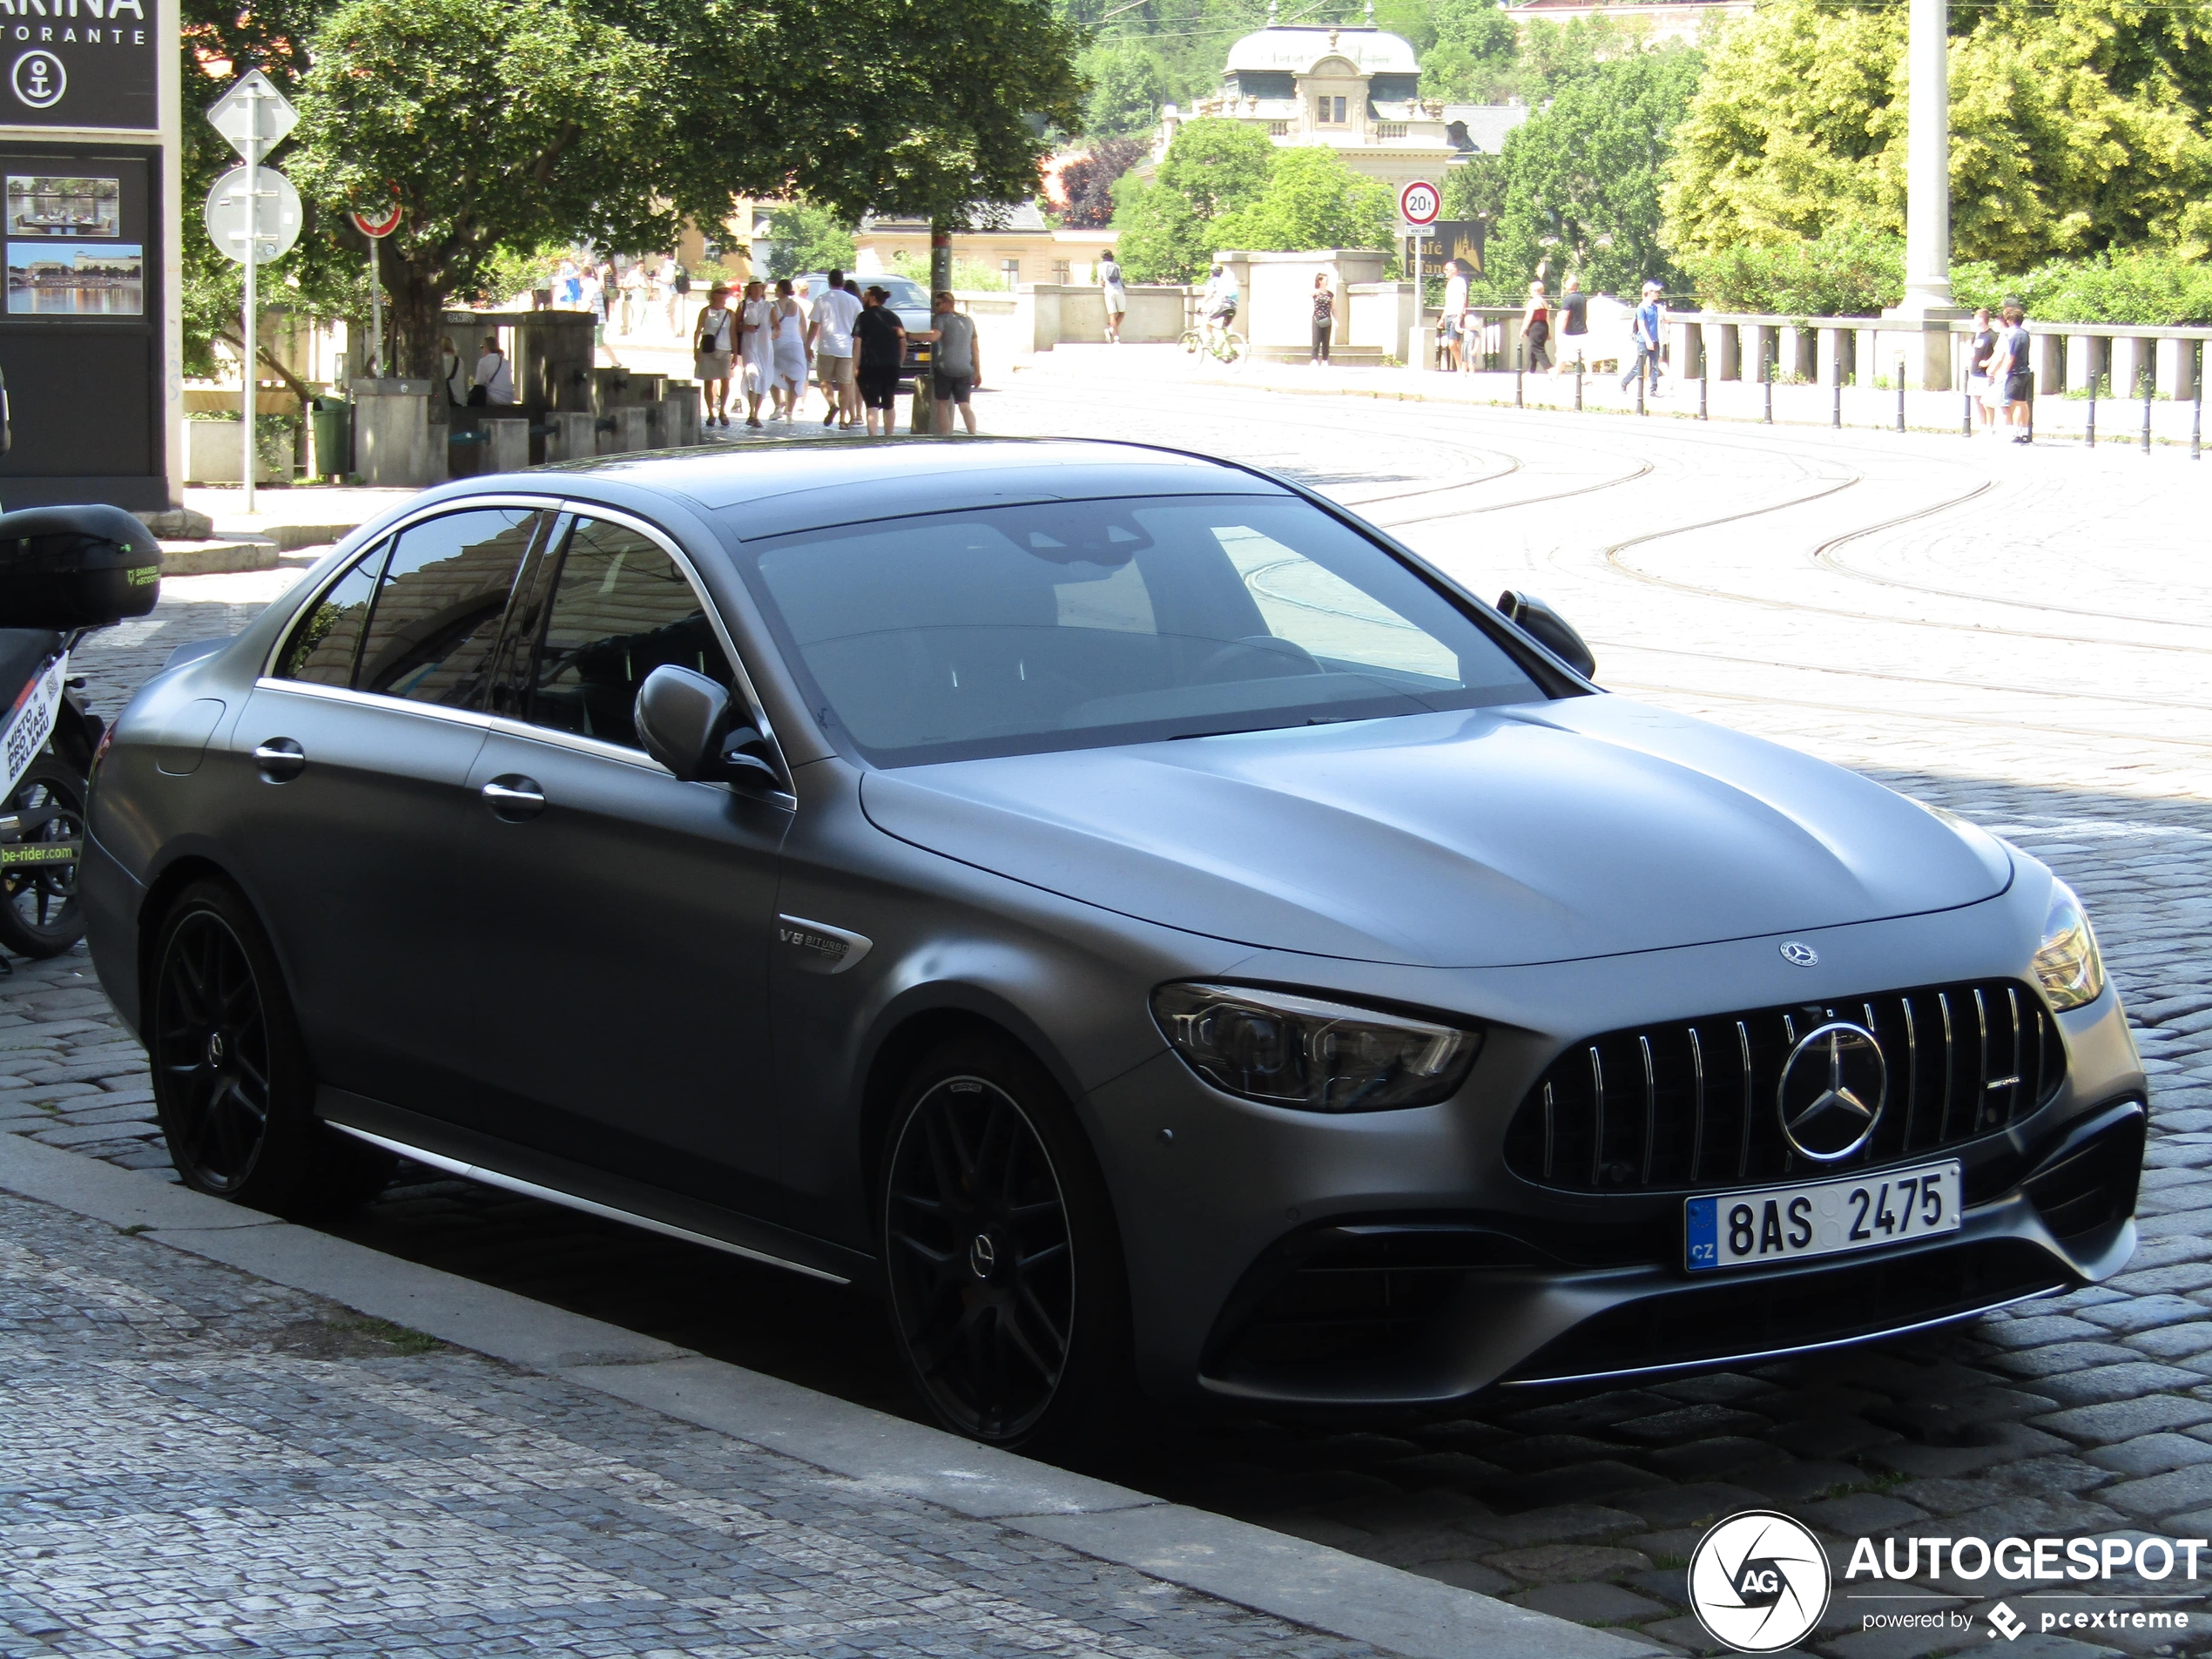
[860,697,2011,967]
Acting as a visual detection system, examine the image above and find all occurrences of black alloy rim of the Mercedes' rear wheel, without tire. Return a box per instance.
[148,909,272,1197]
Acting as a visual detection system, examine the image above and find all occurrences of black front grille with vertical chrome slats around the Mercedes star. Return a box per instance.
[1507,980,2066,1192]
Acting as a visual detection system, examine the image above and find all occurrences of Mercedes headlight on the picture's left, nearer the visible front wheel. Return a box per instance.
[1152,984,1482,1113]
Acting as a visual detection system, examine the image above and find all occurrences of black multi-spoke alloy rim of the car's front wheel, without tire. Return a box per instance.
[882,1064,1103,1445]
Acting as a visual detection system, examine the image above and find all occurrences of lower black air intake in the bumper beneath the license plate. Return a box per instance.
[1504,1238,2068,1383]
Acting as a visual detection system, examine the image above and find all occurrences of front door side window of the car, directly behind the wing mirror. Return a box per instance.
[529,517,737,748]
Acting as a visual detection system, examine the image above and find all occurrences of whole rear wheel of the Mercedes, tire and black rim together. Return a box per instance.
[146,880,394,1219]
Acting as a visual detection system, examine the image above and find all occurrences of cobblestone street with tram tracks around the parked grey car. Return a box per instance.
[0,374,2212,1659]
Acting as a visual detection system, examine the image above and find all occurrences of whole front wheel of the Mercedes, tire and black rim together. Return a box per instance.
[878,1037,1128,1447]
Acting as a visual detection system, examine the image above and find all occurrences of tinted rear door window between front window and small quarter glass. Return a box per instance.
[354,507,550,708]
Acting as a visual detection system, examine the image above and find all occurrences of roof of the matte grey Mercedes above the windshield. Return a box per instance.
[522,438,1291,542]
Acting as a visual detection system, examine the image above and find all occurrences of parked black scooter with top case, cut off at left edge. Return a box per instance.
[0,507,161,955]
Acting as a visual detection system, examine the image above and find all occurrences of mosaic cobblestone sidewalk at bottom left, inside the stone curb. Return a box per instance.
[0,1197,1372,1659]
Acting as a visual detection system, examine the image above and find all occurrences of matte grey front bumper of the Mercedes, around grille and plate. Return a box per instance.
[1082,882,2148,1406]
